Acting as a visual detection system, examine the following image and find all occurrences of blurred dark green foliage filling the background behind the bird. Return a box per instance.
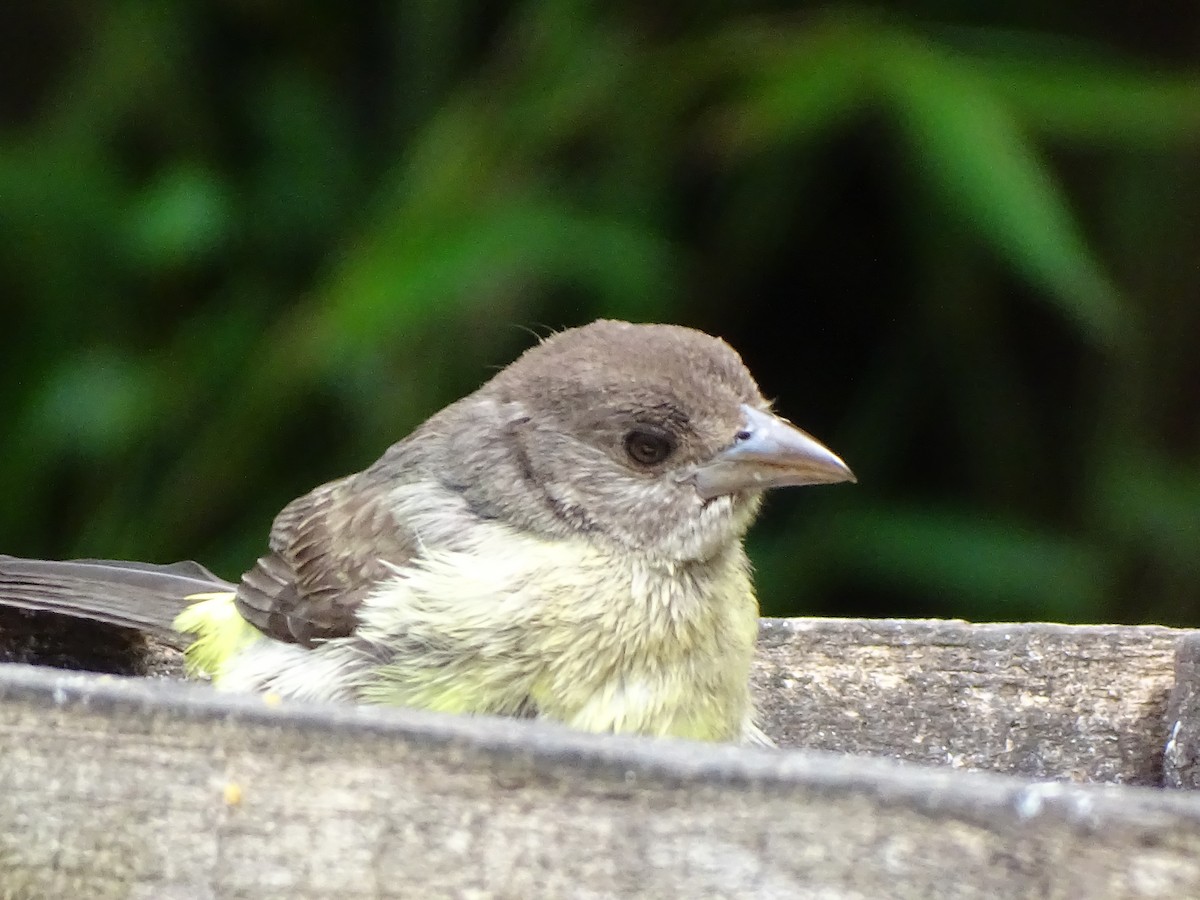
[0,0,1200,624]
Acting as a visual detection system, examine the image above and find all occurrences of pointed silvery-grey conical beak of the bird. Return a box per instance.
[691,404,857,500]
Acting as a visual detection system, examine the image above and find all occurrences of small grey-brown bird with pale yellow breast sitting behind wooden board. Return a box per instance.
[0,319,856,744]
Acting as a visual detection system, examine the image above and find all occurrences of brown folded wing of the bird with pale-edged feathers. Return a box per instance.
[236,475,419,647]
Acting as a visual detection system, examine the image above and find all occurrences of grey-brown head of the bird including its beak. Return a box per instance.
[426,320,853,562]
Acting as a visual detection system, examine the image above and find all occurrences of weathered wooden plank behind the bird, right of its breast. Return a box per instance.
[755,619,1176,785]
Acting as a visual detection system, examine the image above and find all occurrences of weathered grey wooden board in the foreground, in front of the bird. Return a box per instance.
[0,665,1200,900]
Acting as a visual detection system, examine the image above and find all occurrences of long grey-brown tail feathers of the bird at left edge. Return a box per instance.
[0,554,235,643]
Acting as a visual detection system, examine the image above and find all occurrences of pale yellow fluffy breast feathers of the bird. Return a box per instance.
[348,523,757,740]
